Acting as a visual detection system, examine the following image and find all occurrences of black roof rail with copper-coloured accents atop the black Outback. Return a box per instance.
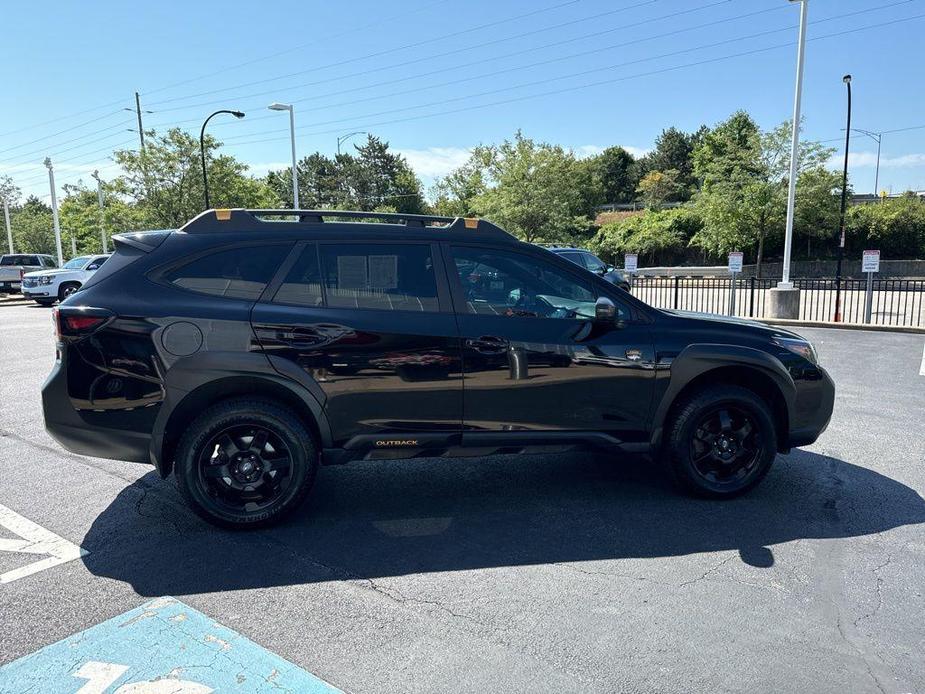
[180,208,513,238]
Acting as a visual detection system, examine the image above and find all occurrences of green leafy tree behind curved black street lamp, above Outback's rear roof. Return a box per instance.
[114,128,279,228]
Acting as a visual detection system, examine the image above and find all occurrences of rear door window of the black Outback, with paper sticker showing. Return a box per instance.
[319,244,439,311]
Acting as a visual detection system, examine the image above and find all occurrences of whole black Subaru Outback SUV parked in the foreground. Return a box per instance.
[42,209,834,527]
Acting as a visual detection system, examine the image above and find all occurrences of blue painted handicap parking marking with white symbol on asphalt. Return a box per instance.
[0,598,341,694]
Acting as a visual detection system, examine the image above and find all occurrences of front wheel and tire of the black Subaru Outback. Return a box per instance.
[664,385,777,499]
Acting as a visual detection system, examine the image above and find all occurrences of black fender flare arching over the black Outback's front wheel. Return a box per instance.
[651,343,797,447]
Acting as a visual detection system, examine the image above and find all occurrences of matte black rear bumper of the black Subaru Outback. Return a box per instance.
[42,361,151,463]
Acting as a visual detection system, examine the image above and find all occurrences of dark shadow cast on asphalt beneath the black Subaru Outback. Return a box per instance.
[82,451,925,596]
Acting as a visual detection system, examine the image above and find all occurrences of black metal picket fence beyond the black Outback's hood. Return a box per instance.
[632,277,925,327]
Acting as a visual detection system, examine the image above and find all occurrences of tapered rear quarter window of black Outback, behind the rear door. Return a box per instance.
[161,245,291,300]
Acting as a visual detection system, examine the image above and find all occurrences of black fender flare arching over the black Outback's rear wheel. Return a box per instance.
[148,352,333,477]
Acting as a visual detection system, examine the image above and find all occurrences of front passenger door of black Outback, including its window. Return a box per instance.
[447,245,655,441]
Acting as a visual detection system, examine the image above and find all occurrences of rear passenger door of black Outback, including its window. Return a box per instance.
[252,241,462,447]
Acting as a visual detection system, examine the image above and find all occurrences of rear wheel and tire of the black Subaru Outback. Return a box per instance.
[175,398,319,528]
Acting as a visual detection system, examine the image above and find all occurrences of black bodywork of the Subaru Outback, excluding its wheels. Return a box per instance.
[43,210,834,484]
